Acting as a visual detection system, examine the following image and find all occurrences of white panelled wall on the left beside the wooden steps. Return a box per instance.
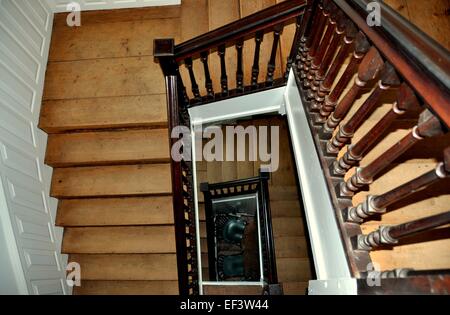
[0,0,68,294]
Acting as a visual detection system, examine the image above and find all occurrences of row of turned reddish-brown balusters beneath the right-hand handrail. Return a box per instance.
[296,0,450,251]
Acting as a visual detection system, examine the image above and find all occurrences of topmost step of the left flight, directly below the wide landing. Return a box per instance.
[39,94,167,133]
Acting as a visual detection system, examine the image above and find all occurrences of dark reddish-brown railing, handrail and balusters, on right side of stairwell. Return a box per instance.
[294,0,450,294]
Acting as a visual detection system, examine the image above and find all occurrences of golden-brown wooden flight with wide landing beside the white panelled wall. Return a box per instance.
[39,7,180,294]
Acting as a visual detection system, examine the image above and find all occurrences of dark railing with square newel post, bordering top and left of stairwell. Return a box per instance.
[154,0,311,295]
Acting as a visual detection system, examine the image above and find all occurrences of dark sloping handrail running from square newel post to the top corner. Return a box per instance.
[175,0,311,62]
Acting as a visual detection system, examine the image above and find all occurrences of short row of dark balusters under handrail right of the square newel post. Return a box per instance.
[180,24,286,104]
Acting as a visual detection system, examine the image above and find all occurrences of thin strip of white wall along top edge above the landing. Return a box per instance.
[47,0,181,12]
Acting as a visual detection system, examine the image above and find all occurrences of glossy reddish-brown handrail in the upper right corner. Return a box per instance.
[334,0,450,126]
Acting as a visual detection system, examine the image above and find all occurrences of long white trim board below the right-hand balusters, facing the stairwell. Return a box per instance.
[285,70,351,280]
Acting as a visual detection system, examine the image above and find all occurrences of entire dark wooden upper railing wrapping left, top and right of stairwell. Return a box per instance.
[155,0,450,293]
